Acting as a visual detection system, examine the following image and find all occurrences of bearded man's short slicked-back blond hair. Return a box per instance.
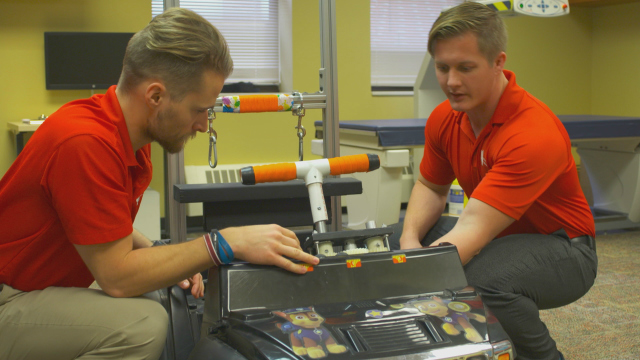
[118,8,233,101]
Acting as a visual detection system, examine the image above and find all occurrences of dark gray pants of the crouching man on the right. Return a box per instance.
[389,216,598,360]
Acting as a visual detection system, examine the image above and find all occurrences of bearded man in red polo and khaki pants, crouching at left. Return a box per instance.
[0,8,318,359]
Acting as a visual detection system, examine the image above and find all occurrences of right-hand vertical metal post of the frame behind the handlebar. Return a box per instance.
[320,0,342,231]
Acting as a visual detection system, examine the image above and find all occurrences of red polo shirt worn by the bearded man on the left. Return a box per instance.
[0,86,151,291]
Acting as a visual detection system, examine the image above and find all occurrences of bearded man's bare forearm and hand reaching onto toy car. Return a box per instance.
[75,224,319,297]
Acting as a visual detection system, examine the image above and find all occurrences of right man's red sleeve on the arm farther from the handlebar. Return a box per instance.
[471,122,570,220]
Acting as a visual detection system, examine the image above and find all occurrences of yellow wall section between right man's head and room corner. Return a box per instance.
[506,7,592,115]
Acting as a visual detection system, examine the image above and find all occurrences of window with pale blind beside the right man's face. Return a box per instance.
[370,0,462,95]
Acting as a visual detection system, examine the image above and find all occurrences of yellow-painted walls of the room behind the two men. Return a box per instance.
[0,0,640,214]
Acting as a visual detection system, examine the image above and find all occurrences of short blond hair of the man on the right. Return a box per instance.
[427,2,507,62]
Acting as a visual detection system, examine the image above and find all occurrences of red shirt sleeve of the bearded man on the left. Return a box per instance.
[41,135,133,245]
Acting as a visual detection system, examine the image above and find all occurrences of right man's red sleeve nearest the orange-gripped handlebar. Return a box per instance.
[420,104,456,185]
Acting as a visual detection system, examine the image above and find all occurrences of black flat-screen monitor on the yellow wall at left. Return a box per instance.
[44,32,134,90]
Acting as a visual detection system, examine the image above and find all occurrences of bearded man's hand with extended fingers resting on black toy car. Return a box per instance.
[220,225,320,274]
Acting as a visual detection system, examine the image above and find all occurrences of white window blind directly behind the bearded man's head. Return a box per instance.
[151,0,280,85]
